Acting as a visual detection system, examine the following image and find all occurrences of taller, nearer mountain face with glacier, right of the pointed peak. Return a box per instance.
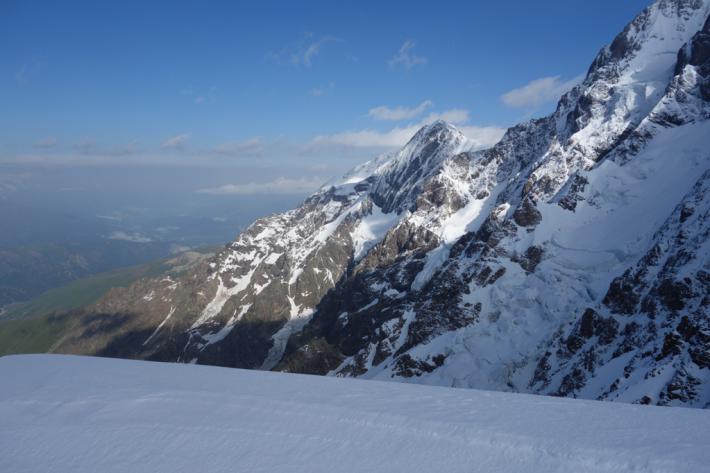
[281,1,710,406]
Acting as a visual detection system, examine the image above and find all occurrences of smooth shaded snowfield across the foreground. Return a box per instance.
[0,355,710,473]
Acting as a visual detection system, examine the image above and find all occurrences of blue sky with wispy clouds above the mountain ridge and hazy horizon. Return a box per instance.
[0,0,647,194]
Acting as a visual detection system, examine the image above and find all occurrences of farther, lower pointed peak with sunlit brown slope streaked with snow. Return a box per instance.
[58,121,471,369]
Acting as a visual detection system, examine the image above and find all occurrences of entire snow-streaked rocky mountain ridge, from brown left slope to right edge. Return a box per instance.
[57,0,710,407]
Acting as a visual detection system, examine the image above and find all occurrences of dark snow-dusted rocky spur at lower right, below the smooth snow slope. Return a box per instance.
[531,171,710,407]
